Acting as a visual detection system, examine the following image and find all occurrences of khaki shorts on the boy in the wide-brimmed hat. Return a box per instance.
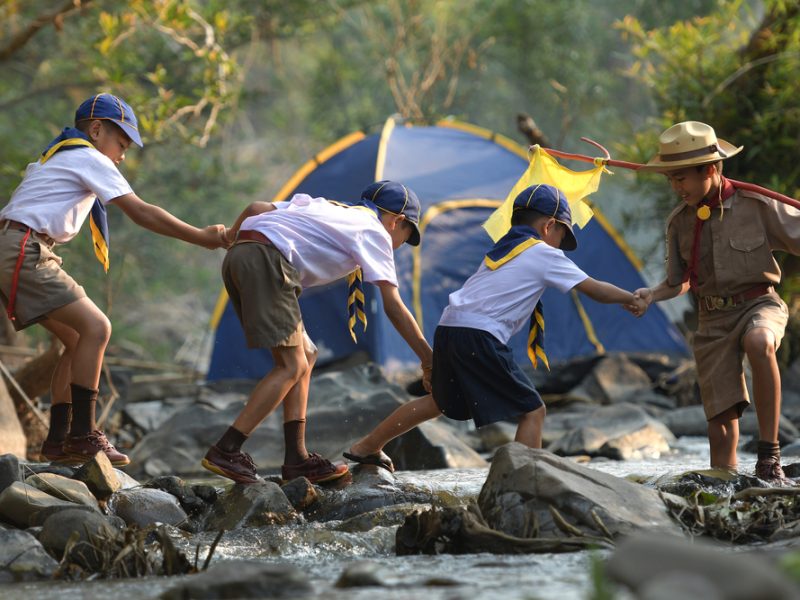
[694,292,789,419]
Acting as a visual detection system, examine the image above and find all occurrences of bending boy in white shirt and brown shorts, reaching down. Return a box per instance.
[202,181,432,483]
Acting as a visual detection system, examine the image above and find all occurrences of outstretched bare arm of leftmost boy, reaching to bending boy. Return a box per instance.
[111,192,228,250]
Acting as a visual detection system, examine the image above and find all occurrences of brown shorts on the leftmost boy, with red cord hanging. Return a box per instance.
[0,226,86,331]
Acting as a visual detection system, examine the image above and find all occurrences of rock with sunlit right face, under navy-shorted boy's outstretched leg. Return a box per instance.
[382,421,487,471]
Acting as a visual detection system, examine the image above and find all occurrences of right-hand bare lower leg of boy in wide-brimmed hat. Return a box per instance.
[743,327,781,442]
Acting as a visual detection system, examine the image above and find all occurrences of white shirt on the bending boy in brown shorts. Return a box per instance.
[240,194,397,287]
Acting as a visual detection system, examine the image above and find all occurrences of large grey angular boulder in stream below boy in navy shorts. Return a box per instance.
[478,442,680,538]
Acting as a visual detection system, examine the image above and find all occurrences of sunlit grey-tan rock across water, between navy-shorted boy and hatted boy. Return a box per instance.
[545,403,675,460]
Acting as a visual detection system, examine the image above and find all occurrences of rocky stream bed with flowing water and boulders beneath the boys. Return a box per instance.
[0,356,800,600]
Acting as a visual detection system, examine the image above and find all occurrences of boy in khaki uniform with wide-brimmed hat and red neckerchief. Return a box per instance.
[636,121,800,483]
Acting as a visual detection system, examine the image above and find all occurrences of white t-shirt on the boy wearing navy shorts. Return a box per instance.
[439,242,589,344]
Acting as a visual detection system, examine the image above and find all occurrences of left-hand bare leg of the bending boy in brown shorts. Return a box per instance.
[233,345,311,436]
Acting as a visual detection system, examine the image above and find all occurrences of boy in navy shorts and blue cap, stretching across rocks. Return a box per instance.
[344,185,634,471]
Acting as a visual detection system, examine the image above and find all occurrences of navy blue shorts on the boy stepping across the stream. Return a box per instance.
[431,325,544,427]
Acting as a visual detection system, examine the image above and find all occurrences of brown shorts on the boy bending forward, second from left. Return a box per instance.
[222,241,311,349]
